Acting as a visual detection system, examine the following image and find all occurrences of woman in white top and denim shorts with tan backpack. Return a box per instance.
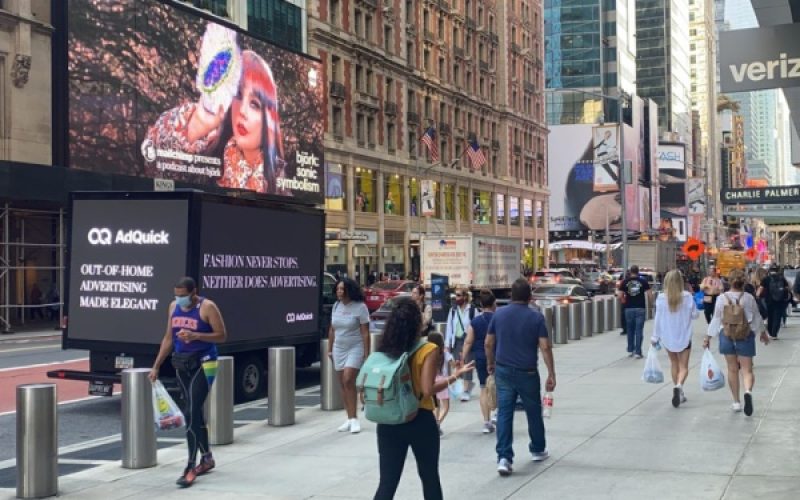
[703,269,769,417]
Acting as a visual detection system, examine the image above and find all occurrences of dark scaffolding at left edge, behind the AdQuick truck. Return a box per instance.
[0,203,66,333]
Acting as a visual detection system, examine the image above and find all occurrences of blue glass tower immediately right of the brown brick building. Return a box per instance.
[544,0,636,125]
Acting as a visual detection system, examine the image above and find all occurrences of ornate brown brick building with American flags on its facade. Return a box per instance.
[308,0,548,279]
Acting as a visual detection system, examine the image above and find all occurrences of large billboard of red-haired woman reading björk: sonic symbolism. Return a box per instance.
[67,0,325,204]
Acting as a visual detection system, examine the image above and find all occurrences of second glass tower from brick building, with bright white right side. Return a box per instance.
[636,0,692,146]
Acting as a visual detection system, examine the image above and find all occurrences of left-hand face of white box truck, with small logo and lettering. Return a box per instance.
[422,236,472,286]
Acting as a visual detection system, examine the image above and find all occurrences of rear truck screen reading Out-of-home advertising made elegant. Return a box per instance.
[67,199,189,344]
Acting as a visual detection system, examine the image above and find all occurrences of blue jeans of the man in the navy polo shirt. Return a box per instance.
[494,365,546,463]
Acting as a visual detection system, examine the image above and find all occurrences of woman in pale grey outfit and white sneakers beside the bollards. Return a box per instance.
[328,278,369,434]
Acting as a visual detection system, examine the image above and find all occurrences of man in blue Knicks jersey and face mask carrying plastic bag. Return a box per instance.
[150,276,228,488]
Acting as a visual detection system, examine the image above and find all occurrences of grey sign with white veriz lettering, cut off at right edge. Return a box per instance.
[719,24,800,92]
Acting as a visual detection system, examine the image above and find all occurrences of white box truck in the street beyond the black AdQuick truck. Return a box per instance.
[422,235,522,299]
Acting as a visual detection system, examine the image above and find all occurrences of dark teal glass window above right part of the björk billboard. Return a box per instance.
[247,0,303,52]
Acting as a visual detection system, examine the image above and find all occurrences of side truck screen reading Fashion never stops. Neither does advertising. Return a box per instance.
[198,202,324,342]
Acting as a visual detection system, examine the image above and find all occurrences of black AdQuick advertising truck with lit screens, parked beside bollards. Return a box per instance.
[48,190,325,401]
